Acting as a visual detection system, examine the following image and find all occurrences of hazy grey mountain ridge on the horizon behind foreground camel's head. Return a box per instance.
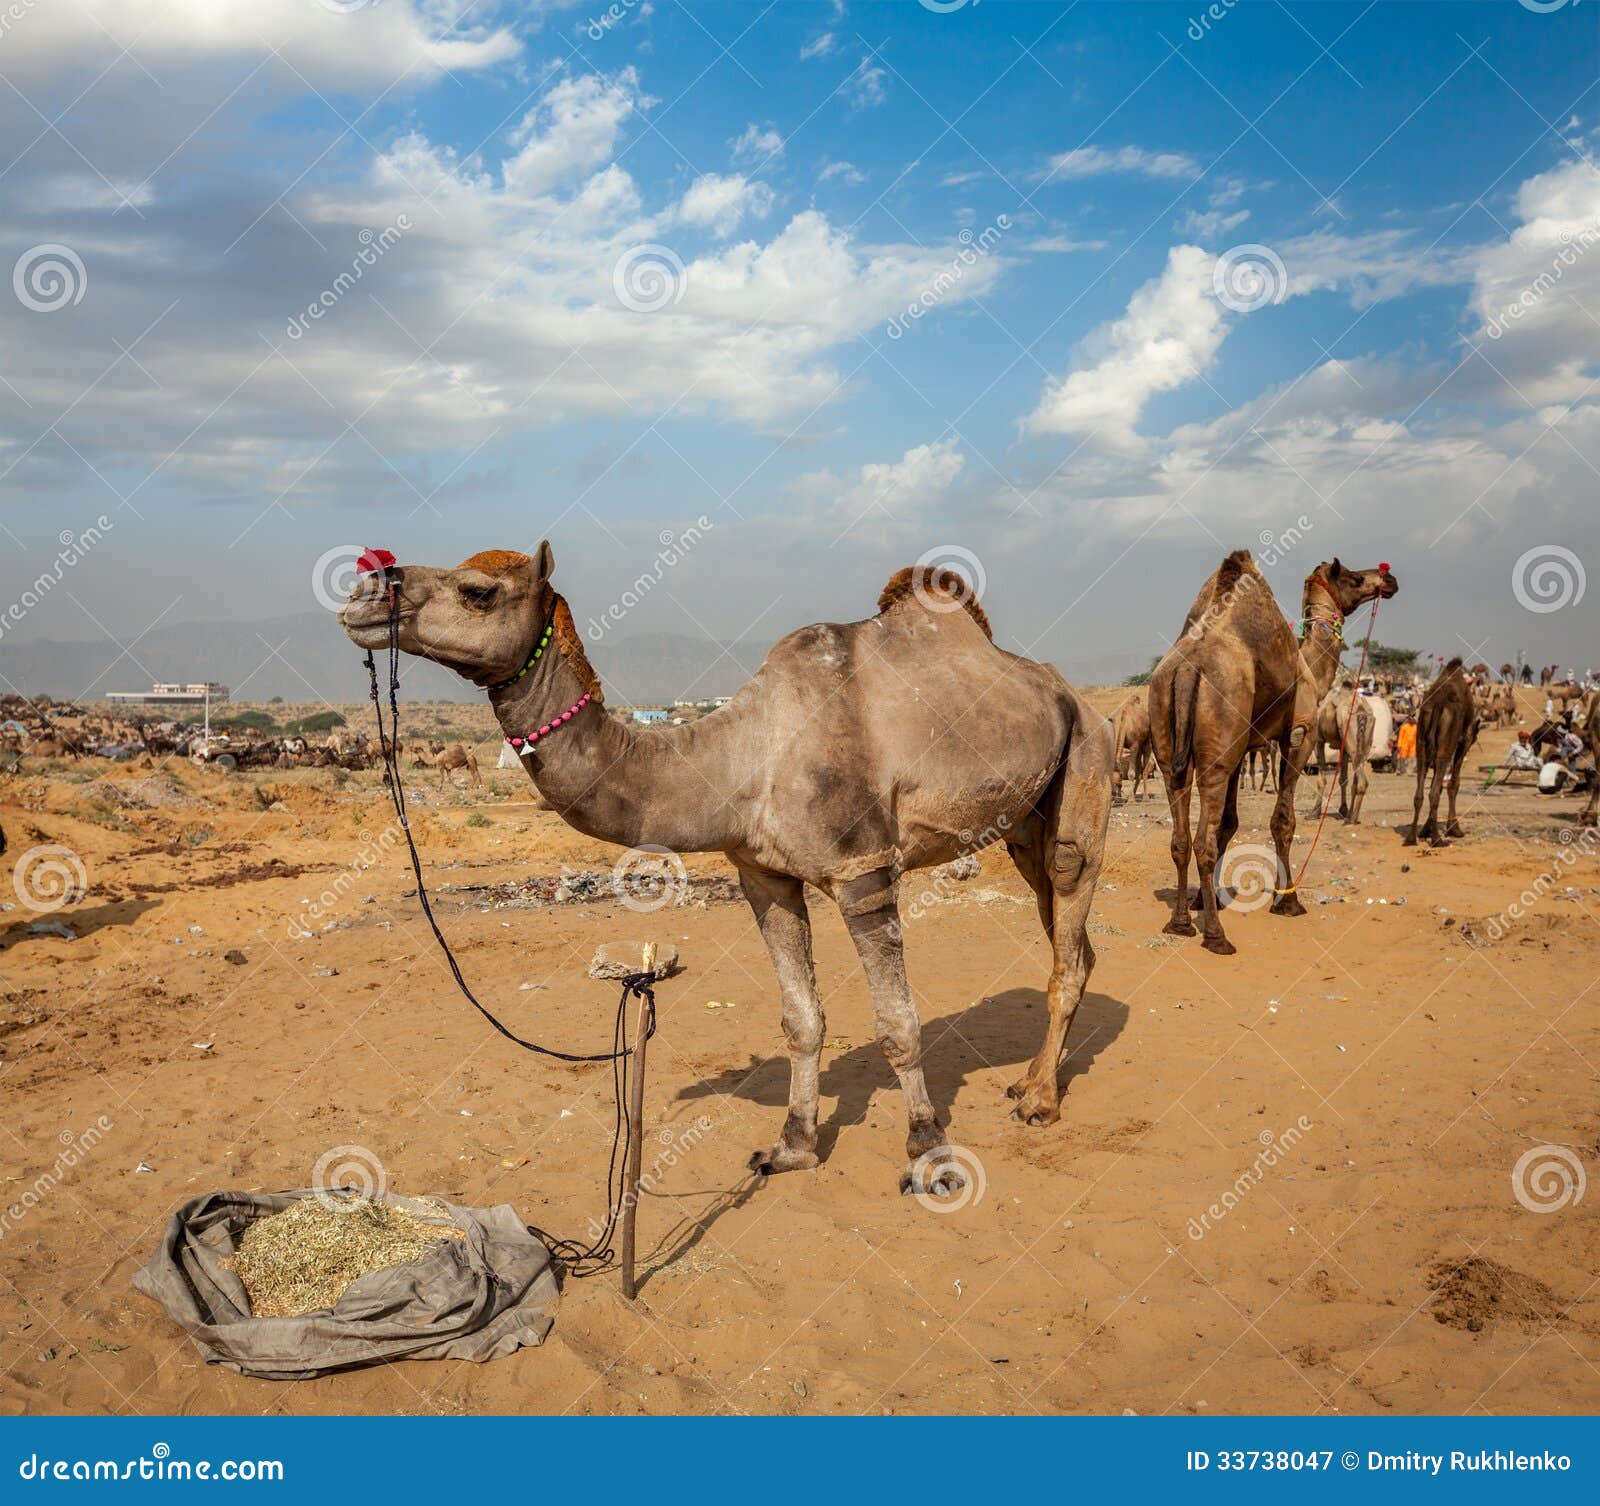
[0,611,771,704]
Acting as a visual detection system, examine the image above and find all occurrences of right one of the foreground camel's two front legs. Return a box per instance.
[834,867,966,1194]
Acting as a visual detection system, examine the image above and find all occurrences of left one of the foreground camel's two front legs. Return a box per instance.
[739,867,826,1175]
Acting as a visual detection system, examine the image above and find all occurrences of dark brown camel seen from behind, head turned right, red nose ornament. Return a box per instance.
[1150,549,1400,955]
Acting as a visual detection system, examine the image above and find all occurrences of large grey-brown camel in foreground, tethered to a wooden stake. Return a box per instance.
[341,541,1112,1194]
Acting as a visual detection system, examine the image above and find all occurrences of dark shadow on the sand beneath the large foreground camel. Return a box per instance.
[677,989,1128,1160]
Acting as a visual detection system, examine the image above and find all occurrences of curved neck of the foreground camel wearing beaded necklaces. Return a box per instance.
[490,614,742,851]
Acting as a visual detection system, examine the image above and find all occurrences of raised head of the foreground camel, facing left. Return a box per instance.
[339,541,557,685]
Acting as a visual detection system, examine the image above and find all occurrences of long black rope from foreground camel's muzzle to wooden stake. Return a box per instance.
[366,581,656,1276]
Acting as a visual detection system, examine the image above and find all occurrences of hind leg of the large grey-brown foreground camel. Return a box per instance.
[1006,723,1110,1125]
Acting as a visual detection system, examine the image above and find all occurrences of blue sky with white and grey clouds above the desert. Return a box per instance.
[0,0,1600,677]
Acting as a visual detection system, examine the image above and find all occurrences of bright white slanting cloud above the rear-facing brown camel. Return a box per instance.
[1027,245,1227,447]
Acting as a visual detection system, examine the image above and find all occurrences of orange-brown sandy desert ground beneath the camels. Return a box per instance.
[0,691,1600,1415]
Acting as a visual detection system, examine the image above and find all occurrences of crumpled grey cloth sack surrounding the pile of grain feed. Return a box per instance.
[133,1189,558,1381]
